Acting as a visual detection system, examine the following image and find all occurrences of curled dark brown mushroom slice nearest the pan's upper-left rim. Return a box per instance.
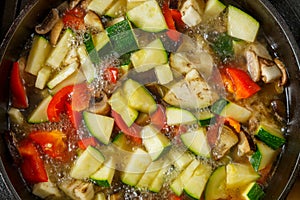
[35,8,59,34]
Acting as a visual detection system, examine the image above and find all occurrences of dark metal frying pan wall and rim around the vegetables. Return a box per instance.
[0,0,300,199]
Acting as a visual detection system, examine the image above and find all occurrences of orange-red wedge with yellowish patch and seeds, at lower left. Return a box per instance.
[28,130,67,160]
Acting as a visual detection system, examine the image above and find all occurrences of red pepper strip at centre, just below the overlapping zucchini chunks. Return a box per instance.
[111,110,142,144]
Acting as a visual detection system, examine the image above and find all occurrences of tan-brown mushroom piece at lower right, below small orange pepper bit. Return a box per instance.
[211,125,239,160]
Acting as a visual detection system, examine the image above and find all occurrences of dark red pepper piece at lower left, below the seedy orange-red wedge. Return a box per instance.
[18,140,48,184]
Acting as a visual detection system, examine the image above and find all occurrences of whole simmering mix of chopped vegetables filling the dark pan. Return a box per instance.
[5,0,287,200]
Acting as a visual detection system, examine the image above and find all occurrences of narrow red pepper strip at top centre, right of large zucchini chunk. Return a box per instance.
[162,3,181,42]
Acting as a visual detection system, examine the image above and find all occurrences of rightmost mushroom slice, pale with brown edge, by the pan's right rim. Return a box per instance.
[259,58,282,83]
